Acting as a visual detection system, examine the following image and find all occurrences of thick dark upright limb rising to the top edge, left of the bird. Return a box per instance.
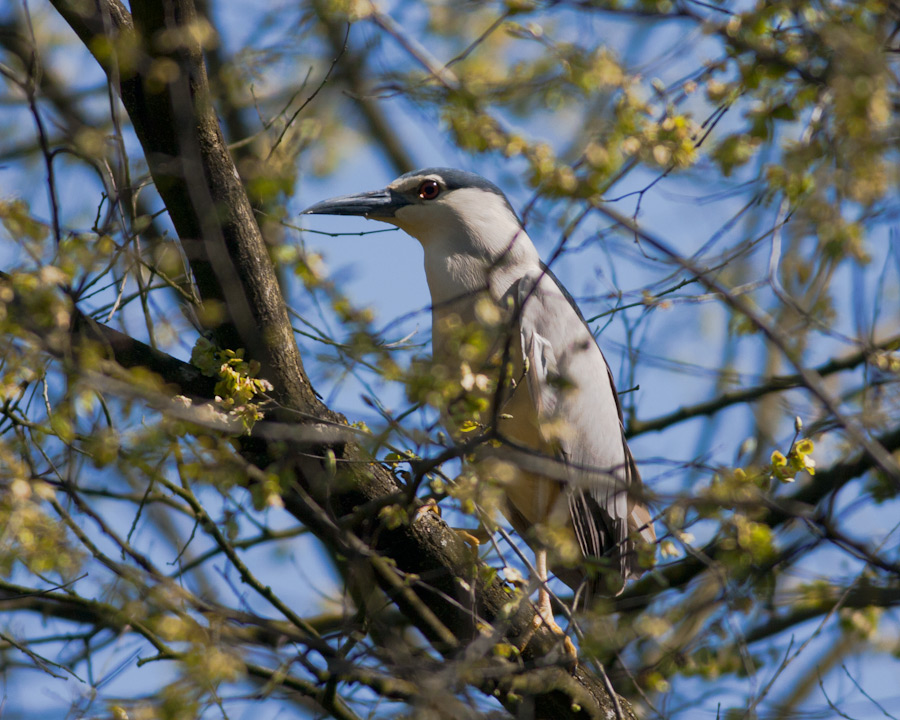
[54,0,325,413]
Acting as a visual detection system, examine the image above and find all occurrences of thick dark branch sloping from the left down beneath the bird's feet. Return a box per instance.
[1,278,633,718]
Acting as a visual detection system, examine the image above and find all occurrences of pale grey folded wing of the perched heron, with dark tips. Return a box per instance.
[514,271,655,591]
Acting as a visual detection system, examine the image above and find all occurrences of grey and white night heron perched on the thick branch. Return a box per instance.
[303,167,656,651]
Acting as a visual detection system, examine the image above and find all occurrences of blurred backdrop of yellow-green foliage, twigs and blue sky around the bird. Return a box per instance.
[0,0,900,719]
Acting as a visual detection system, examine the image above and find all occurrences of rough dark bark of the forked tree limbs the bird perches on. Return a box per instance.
[47,0,633,719]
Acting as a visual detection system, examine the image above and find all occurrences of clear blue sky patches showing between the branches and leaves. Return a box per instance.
[0,3,900,718]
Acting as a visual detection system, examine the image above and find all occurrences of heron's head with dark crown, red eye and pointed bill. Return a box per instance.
[303,168,530,255]
